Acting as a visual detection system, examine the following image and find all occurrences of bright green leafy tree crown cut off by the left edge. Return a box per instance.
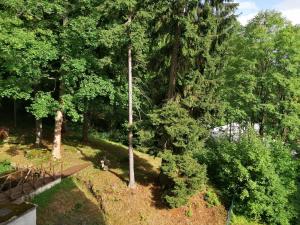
[0,1,57,126]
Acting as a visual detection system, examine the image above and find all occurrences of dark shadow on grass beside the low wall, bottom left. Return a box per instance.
[32,178,106,225]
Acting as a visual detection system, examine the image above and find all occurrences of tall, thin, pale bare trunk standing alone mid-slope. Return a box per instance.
[128,16,135,188]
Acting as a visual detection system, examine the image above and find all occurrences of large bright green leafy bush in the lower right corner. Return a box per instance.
[208,132,297,224]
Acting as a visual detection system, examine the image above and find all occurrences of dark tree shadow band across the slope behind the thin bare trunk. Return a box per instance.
[65,136,167,209]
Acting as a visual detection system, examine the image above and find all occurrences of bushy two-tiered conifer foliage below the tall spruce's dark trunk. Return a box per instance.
[145,102,206,208]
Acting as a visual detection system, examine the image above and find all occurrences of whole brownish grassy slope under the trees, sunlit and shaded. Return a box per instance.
[0,127,226,225]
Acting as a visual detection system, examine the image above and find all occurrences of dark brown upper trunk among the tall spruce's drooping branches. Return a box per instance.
[167,23,181,100]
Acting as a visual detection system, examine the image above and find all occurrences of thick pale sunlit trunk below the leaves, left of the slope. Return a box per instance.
[52,110,63,159]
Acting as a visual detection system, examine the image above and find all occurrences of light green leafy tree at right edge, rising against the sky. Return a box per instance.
[223,11,300,144]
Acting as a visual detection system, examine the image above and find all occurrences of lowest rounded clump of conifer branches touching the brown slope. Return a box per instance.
[161,150,206,208]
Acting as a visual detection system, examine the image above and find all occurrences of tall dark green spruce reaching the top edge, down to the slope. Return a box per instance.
[145,0,237,207]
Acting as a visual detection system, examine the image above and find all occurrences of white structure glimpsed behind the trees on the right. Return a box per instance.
[211,123,260,140]
